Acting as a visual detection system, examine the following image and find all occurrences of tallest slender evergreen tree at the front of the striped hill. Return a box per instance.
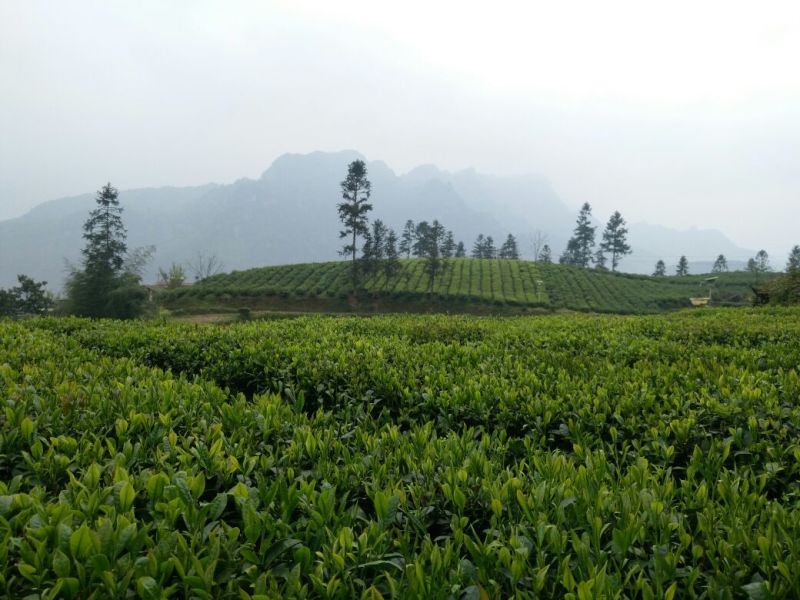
[337,160,372,294]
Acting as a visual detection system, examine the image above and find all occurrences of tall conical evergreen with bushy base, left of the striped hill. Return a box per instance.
[65,183,147,318]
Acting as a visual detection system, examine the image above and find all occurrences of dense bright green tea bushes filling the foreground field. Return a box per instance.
[0,309,800,600]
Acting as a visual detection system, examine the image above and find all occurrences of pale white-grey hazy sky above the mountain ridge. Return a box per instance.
[0,0,800,255]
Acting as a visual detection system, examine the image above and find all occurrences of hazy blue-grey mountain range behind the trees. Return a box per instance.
[0,150,753,290]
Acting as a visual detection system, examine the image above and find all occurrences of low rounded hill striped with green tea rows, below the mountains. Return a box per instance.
[156,258,764,313]
